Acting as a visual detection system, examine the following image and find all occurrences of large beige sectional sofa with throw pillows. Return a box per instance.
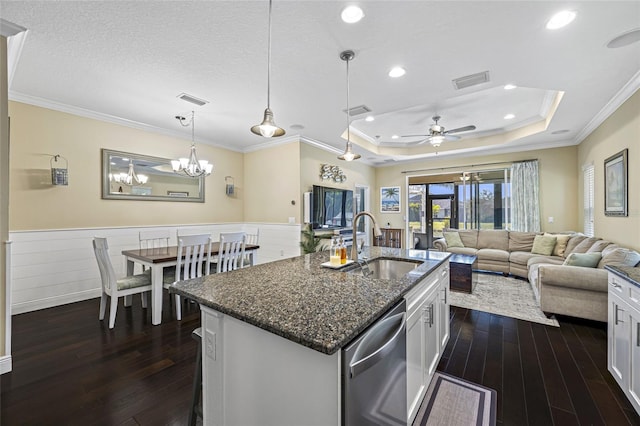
[434,229,640,322]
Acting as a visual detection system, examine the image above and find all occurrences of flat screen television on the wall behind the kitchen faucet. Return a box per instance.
[311,185,353,229]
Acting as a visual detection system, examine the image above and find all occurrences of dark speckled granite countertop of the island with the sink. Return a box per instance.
[170,247,450,355]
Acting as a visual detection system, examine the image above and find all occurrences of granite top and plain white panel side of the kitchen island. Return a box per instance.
[170,247,449,425]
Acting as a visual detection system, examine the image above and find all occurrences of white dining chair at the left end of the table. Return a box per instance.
[93,237,151,328]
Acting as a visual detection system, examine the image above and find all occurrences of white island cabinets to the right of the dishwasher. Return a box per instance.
[405,262,449,424]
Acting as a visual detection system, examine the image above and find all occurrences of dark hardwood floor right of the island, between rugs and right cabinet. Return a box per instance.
[438,306,640,426]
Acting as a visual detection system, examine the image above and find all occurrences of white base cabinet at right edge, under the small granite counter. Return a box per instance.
[607,272,640,413]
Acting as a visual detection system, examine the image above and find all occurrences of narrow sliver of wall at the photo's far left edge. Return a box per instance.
[0,36,10,356]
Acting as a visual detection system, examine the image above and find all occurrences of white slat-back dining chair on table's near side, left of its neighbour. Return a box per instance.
[164,234,211,320]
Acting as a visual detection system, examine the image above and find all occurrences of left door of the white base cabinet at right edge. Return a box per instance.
[608,293,631,389]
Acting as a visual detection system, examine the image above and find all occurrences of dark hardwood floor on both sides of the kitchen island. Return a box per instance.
[0,294,640,426]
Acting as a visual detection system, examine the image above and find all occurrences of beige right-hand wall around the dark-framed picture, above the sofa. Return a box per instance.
[577,91,640,250]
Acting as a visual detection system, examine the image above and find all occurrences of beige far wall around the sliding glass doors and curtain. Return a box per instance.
[373,146,582,232]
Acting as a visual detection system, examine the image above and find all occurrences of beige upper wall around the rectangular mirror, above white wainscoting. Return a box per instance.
[9,102,244,231]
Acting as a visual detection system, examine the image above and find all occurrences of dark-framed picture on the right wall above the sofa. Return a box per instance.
[604,149,628,216]
